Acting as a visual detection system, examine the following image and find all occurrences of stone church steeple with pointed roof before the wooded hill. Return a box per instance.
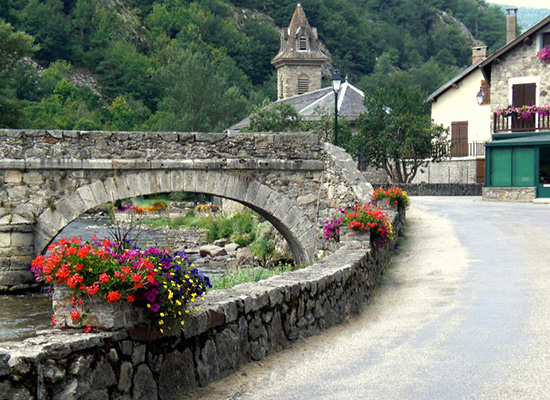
[271,3,328,99]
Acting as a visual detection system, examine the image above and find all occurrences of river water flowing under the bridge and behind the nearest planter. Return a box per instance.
[0,218,226,342]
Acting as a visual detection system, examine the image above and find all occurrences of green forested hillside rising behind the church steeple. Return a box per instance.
[0,0,505,131]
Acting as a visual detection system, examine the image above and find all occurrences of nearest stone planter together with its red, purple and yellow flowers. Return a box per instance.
[31,237,211,333]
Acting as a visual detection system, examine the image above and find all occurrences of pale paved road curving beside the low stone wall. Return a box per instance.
[189,197,550,400]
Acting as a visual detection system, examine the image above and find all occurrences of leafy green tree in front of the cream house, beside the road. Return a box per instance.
[354,85,449,183]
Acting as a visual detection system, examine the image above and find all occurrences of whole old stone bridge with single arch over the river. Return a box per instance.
[0,130,372,292]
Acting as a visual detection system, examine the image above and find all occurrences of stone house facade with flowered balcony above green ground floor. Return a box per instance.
[481,16,550,201]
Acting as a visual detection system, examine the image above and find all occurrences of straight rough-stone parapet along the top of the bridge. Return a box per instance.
[0,129,321,162]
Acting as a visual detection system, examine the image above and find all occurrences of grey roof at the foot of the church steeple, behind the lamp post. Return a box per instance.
[227,81,367,132]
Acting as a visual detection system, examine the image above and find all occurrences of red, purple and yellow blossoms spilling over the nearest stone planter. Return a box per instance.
[31,237,211,333]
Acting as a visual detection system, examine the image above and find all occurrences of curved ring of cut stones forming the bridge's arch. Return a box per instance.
[34,170,317,263]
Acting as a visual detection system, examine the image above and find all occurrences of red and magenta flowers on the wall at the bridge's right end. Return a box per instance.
[323,204,395,247]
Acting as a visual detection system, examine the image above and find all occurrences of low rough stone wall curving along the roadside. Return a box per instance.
[0,212,404,400]
